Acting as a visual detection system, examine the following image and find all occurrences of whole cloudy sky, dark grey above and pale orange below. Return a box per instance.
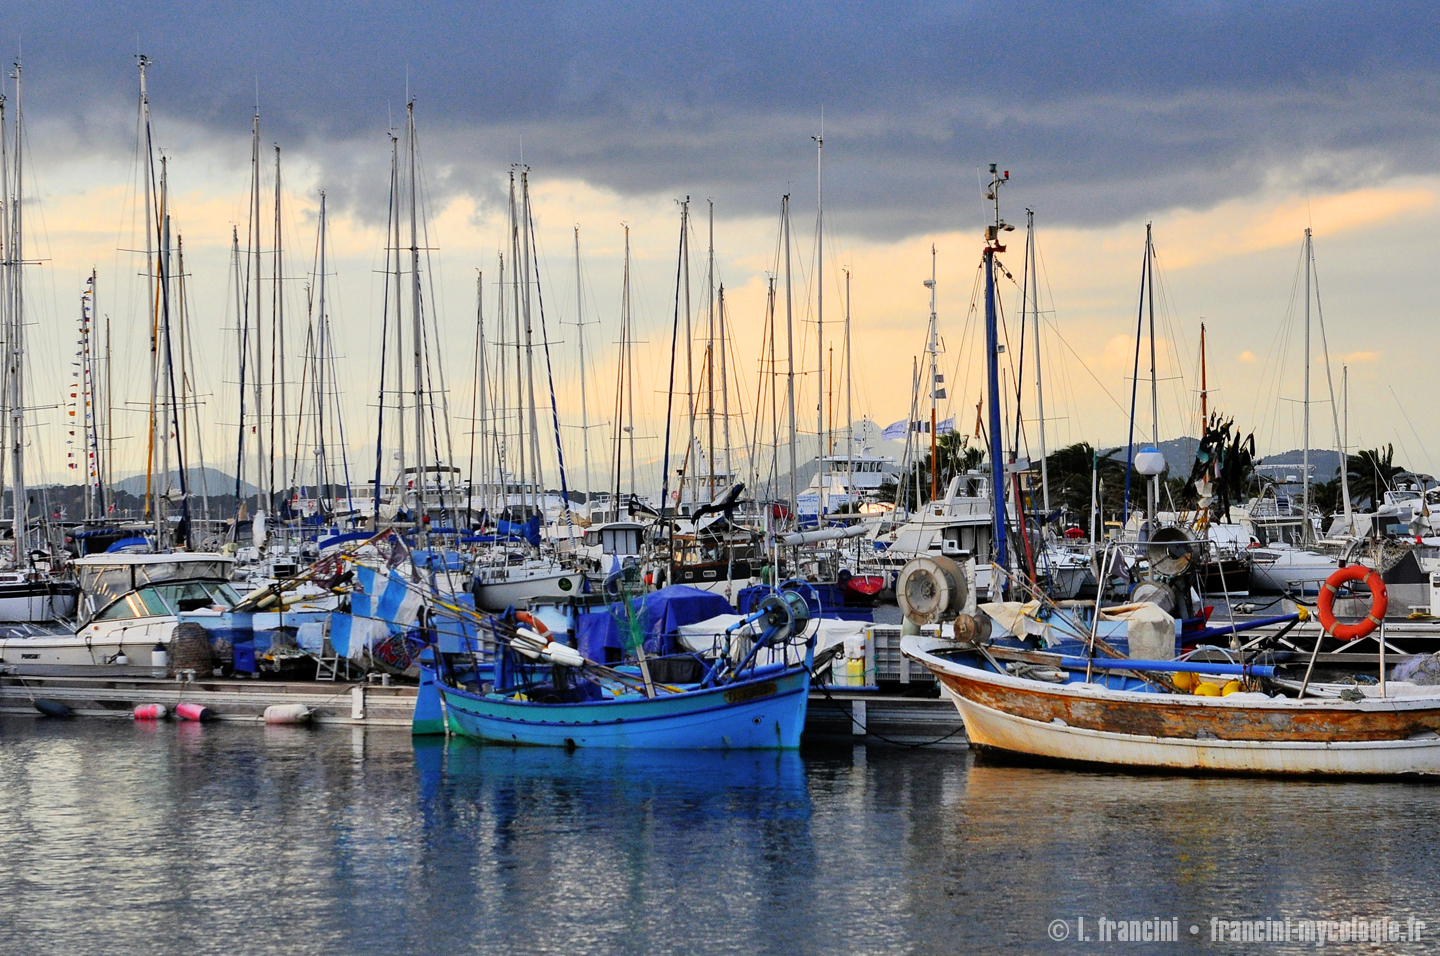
[0,1,1440,485]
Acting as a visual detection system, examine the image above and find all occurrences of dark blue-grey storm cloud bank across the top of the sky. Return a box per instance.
[6,0,1440,236]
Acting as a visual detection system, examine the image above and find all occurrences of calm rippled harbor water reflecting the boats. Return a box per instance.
[0,717,1440,956]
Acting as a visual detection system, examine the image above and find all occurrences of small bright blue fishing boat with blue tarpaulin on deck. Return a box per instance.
[415,596,815,750]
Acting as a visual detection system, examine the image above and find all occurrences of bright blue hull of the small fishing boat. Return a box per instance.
[438,668,809,750]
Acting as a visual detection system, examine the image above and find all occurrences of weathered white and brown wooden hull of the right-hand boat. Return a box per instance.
[906,638,1440,775]
